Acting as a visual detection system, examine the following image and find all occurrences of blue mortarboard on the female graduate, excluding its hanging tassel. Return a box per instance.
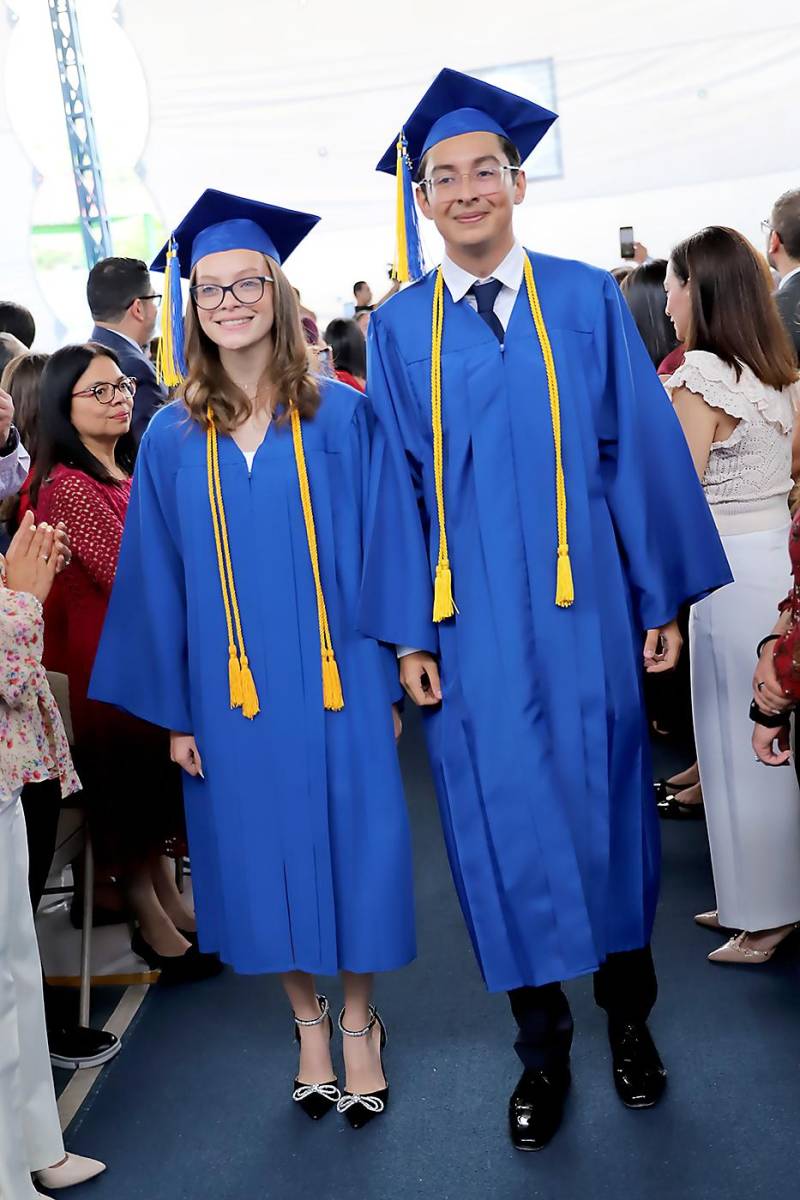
[150,187,319,280]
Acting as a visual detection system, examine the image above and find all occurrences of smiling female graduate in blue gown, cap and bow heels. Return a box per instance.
[92,190,415,1128]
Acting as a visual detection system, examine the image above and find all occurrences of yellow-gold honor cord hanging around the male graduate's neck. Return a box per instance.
[431,254,575,622]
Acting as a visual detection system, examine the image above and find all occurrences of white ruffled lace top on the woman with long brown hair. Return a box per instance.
[666,350,800,533]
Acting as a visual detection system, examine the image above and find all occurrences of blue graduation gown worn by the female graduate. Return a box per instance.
[91,382,415,974]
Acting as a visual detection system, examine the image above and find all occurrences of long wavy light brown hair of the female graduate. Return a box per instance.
[180,254,320,433]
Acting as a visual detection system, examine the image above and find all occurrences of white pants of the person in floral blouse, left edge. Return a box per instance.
[0,797,64,1200]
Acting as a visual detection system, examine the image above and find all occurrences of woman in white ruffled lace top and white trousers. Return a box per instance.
[664,227,800,964]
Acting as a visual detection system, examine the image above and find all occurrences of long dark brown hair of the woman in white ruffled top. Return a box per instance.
[669,226,798,388]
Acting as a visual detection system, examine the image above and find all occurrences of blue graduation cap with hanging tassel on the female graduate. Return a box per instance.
[150,187,319,388]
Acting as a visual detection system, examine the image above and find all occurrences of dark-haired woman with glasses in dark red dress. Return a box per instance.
[30,342,221,980]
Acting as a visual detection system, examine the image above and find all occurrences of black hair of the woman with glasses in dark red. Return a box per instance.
[30,342,136,505]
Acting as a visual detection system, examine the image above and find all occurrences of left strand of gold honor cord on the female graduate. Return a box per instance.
[206,408,260,720]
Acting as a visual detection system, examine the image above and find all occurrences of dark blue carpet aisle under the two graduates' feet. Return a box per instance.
[56,710,800,1200]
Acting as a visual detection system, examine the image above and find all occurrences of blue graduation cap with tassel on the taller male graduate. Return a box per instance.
[375,67,558,282]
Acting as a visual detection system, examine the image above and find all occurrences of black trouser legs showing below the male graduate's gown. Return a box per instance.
[509,946,658,1070]
